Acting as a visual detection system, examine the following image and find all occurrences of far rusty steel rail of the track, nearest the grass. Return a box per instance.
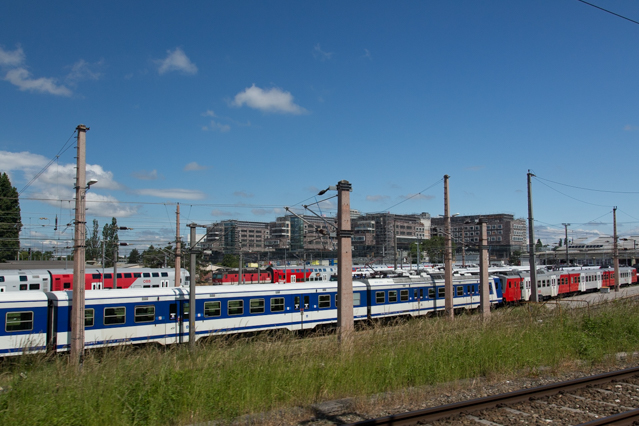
[348,367,639,426]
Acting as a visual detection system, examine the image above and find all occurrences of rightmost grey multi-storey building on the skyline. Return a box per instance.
[431,213,527,260]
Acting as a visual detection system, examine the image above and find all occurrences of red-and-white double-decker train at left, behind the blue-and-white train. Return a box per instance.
[0,268,189,293]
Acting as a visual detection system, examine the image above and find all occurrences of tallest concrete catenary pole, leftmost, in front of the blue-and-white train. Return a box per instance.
[71,124,89,365]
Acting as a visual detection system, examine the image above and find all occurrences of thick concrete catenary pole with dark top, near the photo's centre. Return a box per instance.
[337,180,354,343]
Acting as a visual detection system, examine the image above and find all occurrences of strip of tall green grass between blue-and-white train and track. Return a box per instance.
[0,301,639,425]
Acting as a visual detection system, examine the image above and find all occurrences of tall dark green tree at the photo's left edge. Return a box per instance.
[0,173,22,262]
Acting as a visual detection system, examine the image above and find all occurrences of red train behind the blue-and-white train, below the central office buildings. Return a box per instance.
[212,265,337,285]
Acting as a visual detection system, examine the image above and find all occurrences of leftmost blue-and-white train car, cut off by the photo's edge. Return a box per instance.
[0,291,49,356]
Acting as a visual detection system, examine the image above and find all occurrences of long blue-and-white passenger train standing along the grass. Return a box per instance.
[0,274,502,356]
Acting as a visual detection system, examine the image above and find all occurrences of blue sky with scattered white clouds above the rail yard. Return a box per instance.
[0,0,639,256]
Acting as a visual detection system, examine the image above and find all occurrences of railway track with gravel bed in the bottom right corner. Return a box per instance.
[351,367,639,426]
